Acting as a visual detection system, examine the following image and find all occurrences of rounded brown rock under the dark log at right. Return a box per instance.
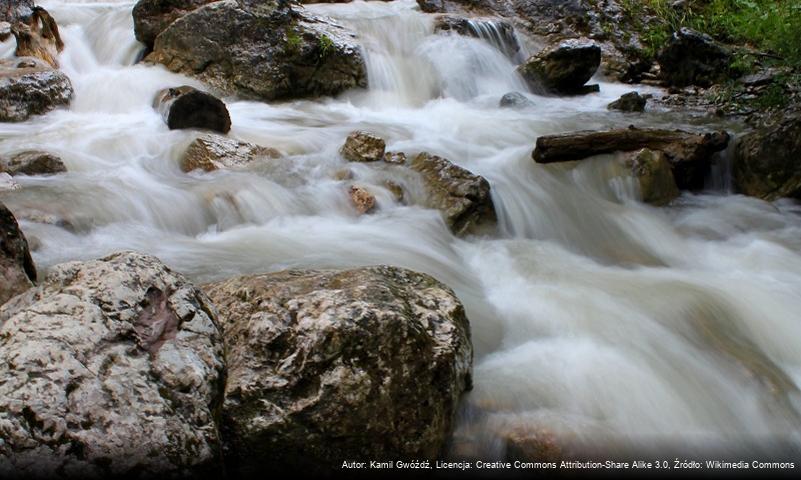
[623,148,679,206]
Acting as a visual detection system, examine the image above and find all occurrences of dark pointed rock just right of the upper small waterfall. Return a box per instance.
[518,40,601,95]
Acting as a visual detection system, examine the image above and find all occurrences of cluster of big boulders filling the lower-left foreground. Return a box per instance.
[0,205,472,478]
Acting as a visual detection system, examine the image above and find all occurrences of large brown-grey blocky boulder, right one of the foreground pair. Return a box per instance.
[206,266,472,477]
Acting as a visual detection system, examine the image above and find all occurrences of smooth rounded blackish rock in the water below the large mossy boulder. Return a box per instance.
[153,85,231,133]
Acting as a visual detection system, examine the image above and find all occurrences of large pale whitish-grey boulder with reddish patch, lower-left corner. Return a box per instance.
[0,253,224,478]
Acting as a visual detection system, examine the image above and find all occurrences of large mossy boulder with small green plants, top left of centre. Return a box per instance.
[146,0,367,100]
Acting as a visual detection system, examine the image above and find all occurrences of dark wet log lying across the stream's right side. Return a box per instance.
[532,127,729,190]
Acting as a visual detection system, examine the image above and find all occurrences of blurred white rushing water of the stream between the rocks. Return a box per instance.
[0,0,801,464]
